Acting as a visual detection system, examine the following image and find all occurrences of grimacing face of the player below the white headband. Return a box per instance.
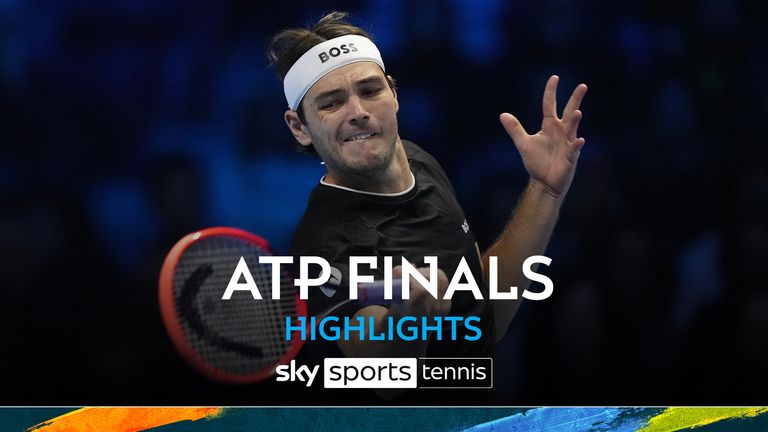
[286,62,398,178]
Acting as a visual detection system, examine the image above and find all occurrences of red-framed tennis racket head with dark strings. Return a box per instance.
[159,227,307,384]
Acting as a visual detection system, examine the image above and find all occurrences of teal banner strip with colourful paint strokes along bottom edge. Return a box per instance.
[0,407,768,432]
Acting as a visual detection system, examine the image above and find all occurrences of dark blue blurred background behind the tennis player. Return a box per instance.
[0,0,768,405]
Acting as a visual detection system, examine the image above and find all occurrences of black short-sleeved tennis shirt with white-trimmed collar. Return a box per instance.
[291,141,494,360]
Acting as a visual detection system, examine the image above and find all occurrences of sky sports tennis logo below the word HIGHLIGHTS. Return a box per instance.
[275,357,493,389]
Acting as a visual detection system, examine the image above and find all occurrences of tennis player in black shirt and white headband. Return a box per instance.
[269,12,587,402]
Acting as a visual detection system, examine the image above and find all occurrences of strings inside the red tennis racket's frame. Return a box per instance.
[173,236,297,375]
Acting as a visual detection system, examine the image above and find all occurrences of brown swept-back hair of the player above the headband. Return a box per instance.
[267,11,395,156]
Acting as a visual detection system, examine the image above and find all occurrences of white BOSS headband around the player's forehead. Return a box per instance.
[283,35,384,111]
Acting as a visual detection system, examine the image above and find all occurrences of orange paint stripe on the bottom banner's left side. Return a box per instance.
[27,407,222,432]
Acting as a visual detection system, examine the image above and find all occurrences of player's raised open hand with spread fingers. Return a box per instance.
[499,75,587,197]
